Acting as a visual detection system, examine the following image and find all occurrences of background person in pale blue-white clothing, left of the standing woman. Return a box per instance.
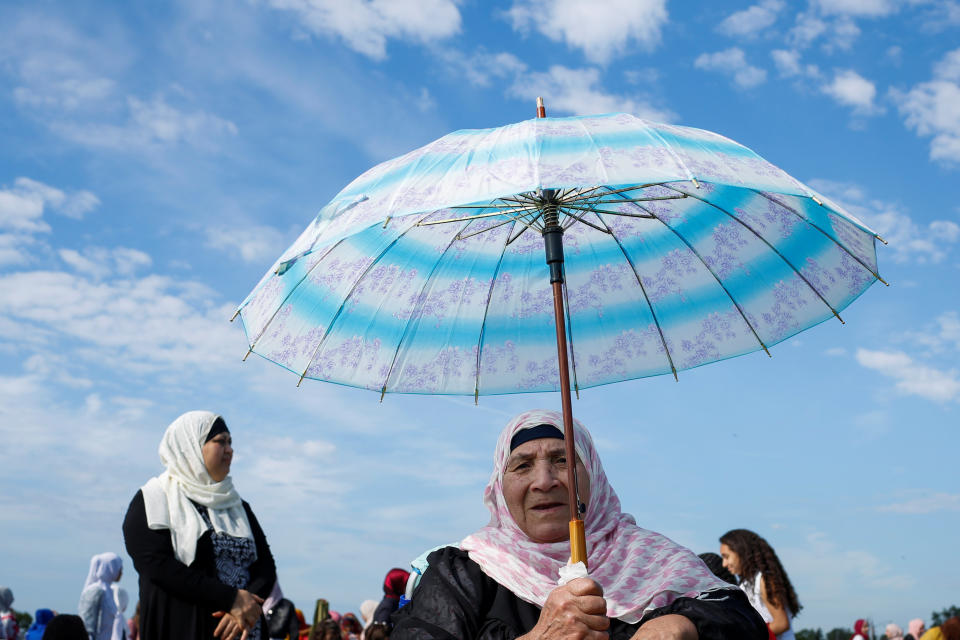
[77,551,127,640]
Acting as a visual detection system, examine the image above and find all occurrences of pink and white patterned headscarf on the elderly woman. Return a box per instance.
[460,410,730,623]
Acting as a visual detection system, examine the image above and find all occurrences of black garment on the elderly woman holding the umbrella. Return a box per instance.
[390,547,768,640]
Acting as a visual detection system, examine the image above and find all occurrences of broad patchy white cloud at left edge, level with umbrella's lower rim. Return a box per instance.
[0,268,242,373]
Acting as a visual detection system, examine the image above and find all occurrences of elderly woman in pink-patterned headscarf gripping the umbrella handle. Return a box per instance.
[390,411,767,640]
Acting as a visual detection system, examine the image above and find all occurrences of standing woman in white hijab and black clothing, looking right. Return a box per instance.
[123,411,277,640]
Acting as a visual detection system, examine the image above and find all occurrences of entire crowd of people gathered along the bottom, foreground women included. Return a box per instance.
[0,411,960,640]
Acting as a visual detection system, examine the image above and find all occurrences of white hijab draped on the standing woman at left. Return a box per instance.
[141,411,253,565]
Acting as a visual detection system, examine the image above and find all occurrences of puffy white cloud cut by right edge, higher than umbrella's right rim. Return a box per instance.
[890,49,960,164]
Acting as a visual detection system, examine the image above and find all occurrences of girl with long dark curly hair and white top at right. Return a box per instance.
[720,529,803,640]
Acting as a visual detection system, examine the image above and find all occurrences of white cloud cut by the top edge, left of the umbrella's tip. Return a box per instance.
[269,0,461,60]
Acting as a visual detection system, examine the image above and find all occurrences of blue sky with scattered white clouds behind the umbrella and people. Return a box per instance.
[0,0,960,628]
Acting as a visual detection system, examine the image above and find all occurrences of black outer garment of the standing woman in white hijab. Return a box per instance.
[123,491,277,640]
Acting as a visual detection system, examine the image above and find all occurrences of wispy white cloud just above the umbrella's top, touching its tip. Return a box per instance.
[509,65,674,122]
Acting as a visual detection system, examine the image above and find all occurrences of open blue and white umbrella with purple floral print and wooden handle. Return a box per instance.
[234,99,882,562]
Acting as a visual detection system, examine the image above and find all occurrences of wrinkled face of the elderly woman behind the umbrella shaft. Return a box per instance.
[503,438,590,542]
